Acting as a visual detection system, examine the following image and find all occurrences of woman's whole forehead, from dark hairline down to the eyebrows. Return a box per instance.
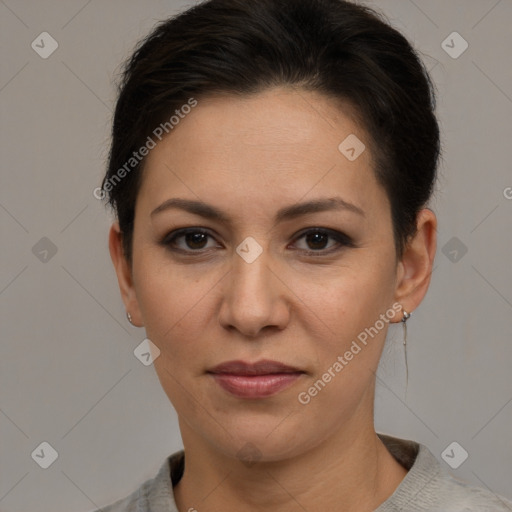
[140,88,388,222]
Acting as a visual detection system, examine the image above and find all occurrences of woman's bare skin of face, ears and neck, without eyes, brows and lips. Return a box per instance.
[109,87,437,512]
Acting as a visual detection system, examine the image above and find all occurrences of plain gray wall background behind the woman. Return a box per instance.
[0,0,512,512]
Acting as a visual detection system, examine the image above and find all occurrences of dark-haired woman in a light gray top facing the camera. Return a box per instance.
[96,0,512,512]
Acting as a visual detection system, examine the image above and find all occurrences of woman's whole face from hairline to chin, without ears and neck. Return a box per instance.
[112,88,432,460]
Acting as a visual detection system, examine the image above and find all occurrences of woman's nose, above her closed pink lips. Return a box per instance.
[219,245,291,340]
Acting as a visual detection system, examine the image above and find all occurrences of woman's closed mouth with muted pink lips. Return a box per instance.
[207,360,305,399]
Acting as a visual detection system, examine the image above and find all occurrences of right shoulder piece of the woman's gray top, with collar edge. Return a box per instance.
[376,434,512,512]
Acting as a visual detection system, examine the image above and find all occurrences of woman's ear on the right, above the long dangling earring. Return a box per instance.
[395,208,437,322]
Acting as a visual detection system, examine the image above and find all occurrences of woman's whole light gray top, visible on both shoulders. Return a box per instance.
[94,433,512,512]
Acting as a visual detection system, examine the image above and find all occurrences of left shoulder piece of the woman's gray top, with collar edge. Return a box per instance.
[92,450,184,512]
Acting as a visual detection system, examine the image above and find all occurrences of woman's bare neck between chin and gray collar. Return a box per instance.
[174,421,407,512]
